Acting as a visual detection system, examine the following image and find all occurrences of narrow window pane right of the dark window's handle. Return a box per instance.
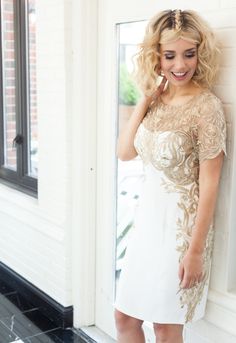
[26,0,38,177]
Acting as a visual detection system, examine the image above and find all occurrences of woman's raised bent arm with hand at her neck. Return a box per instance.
[117,77,166,161]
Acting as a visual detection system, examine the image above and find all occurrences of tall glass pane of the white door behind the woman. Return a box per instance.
[116,21,146,290]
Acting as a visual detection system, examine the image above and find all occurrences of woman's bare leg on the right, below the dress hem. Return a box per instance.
[153,323,184,343]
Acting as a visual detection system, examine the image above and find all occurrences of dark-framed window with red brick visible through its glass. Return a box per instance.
[0,0,38,195]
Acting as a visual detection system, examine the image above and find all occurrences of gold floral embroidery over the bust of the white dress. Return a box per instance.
[135,125,199,185]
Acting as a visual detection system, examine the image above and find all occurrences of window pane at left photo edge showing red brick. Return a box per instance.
[1,0,16,170]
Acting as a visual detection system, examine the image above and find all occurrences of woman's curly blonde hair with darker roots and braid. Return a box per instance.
[134,10,220,95]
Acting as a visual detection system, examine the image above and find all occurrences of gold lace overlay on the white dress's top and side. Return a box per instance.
[134,91,226,323]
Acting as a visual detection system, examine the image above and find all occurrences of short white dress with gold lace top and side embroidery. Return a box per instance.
[114,90,226,324]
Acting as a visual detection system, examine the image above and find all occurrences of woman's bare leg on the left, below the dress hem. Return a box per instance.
[114,310,145,343]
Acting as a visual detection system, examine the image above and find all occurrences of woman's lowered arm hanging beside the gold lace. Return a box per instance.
[179,151,223,288]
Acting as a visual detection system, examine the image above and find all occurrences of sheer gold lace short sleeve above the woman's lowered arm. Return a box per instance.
[198,96,226,163]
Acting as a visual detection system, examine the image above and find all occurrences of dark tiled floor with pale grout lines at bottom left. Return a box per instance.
[0,282,94,343]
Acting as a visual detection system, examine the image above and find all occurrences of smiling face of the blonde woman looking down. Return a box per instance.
[161,38,197,87]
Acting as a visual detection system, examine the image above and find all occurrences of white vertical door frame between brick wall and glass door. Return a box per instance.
[70,0,97,328]
